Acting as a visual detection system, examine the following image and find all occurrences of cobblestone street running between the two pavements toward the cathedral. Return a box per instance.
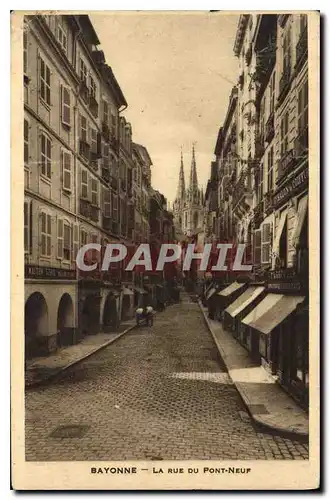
[26,296,308,461]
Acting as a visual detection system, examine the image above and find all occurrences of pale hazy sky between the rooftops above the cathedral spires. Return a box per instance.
[90,11,238,203]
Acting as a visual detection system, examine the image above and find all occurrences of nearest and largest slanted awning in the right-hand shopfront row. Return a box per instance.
[251,295,305,334]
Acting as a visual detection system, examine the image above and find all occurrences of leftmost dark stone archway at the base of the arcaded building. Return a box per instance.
[24,292,49,358]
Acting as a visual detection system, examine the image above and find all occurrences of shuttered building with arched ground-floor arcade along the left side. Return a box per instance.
[23,15,138,357]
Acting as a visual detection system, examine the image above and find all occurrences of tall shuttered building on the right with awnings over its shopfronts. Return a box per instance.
[206,14,309,406]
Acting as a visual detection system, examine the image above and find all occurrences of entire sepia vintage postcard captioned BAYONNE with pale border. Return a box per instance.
[11,11,320,490]
